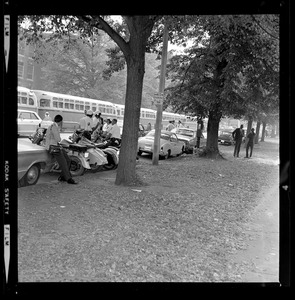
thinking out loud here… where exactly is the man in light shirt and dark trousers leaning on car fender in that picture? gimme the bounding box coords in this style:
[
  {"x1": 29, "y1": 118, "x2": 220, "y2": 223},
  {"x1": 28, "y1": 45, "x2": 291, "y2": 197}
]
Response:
[{"x1": 45, "y1": 115, "x2": 77, "y2": 184}]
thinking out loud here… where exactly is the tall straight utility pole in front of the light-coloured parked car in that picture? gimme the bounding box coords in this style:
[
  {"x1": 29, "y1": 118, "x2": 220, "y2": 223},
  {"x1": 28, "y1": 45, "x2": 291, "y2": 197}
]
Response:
[{"x1": 152, "y1": 20, "x2": 168, "y2": 165}]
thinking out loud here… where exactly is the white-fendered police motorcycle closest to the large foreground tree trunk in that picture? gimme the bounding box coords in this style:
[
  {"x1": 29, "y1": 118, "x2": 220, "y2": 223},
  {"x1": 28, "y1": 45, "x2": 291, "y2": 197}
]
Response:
[{"x1": 69, "y1": 129, "x2": 119, "y2": 172}]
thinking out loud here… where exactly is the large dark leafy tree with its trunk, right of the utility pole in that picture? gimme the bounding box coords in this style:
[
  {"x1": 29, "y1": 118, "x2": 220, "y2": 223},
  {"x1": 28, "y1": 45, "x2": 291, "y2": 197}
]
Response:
[{"x1": 166, "y1": 15, "x2": 279, "y2": 153}]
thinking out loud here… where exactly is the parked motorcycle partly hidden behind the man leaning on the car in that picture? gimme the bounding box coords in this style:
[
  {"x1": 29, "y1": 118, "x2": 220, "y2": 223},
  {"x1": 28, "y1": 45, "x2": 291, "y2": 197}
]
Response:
[{"x1": 29, "y1": 127, "x2": 90, "y2": 176}]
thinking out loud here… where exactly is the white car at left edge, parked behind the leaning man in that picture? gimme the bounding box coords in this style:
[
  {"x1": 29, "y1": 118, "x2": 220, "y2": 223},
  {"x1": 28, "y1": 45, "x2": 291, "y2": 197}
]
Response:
[{"x1": 17, "y1": 109, "x2": 42, "y2": 136}]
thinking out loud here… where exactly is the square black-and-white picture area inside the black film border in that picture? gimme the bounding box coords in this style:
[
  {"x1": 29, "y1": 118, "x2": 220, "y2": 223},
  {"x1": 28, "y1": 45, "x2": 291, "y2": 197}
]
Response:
[{"x1": 3, "y1": 0, "x2": 290, "y2": 296}]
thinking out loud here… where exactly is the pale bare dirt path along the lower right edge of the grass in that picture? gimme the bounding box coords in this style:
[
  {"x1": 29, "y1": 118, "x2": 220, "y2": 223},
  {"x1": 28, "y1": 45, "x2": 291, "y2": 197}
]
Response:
[{"x1": 233, "y1": 176, "x2": 279, "y2": 282}]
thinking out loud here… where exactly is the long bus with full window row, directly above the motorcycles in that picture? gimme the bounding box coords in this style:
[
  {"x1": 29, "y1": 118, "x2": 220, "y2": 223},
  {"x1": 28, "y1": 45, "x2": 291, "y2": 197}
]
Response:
[{"x1": 33, "y1": 90, "x2": 117, "y2": 122}]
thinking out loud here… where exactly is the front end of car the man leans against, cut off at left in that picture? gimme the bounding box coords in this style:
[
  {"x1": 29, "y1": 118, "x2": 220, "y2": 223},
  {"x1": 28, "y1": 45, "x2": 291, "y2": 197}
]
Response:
[{"x1": 17, "y1": 138, "x2": 51, "y2": 187}]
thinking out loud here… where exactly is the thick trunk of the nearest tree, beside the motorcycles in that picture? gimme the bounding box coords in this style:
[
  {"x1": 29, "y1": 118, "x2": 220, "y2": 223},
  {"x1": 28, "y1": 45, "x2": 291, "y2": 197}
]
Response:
[{"x1": 115, "y1": 24, "x2": 147, "y2": 185}]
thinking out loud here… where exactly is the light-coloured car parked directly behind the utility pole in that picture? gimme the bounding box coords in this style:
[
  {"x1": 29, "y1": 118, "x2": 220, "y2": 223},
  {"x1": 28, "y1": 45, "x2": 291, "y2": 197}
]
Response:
[{"x1": 138, "y1": 130, "x2": 185, "y2": 158}]
